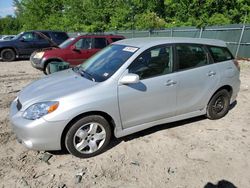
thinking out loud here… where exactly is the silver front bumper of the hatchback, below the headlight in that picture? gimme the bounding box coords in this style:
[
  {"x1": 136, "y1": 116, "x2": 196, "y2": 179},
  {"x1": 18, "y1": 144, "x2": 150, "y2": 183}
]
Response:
[{"x1": 10, "y1": 99, "x2": 67, "y2": 151}]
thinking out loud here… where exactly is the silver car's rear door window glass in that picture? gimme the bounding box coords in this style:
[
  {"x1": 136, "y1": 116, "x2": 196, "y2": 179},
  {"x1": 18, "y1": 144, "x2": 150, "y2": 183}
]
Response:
[{"x1": 176, "y1": 44, "x2": 209, "y2": 70}]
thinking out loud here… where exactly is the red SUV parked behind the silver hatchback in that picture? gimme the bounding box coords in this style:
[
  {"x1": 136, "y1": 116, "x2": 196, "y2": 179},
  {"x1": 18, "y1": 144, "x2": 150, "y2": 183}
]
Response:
[{"x1": 30, "y1": 35, "x2": 125, "y2": 74}]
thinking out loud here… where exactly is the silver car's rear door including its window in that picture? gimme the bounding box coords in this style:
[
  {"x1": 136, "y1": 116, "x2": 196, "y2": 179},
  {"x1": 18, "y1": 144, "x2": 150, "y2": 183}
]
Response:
[{"x1": 175, "y1": 44, "x2": 219, "y2": 115}]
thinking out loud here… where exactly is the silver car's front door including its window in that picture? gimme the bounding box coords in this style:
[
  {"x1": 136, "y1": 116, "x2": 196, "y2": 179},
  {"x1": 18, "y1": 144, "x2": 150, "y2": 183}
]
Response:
[{"x1": 118, "y1": 46, "x2": 177, "y2": 128}]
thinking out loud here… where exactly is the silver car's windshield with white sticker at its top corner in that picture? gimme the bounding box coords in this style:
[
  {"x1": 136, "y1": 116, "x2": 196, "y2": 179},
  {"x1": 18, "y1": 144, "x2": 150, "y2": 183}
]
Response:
[{"x1": 75, "y1": 44, "x2": 138, "y2": 82}]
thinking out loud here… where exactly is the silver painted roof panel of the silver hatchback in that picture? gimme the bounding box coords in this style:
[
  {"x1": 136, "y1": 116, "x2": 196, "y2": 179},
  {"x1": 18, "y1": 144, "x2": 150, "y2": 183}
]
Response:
[{"x1": 114, "y1": 37, "x2": 226, "y2": 48}]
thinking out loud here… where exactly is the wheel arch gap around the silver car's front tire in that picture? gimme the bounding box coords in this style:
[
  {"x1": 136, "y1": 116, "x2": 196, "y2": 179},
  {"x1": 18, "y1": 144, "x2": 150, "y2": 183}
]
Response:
[{"x1": 60, "y1": 111, "x2": 115, "y2": 150}]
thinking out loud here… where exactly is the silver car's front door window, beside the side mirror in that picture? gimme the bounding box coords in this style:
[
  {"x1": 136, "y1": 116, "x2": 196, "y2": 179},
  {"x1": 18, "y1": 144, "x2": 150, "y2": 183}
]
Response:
[{"x1": 128, "y1": 46, "x2": 173, "y2": 79}]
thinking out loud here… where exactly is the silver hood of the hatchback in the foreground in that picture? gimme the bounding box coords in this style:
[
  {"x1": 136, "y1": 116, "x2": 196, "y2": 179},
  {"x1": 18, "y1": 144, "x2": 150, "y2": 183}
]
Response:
[{"x1": 18, "y1": 69, "x2": 97, "y2": 109}]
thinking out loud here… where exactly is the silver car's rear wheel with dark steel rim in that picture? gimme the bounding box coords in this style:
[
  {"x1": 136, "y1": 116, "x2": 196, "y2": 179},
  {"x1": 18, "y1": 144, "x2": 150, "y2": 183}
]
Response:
[{"x1": 207, "y1": 89, "x2": 230, "y2": 120}]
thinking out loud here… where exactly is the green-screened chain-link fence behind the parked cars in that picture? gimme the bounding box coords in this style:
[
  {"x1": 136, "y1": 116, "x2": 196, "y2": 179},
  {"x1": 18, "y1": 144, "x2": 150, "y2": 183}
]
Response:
[{"x1": 70, "y1": 24, "x2": 250, "y2": 58}]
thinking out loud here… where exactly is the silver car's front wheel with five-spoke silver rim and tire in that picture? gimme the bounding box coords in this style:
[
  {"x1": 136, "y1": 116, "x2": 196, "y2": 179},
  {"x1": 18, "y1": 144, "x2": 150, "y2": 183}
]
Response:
[{"x1": 65, "y1": 115, "x2": 111, "y2": 158}]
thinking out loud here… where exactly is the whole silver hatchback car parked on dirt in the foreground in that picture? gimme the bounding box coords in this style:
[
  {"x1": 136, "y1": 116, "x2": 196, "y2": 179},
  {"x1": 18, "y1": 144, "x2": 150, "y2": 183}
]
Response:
[{"x1": 10, "y1": 38, "x2": 240, "y2": 158}]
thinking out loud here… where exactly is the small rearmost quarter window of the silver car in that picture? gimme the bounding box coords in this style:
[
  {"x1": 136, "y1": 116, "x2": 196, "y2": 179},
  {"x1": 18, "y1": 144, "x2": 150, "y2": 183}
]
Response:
[{"x1": 208, "y1": 46, "x2": 234, "y2": 63}]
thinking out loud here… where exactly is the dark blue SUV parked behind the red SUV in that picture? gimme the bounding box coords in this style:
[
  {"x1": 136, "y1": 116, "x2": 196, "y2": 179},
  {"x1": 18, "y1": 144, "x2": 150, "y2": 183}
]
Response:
[{"x1": 0, "y1": 31, "x2": 69, "y2": 61}]
